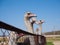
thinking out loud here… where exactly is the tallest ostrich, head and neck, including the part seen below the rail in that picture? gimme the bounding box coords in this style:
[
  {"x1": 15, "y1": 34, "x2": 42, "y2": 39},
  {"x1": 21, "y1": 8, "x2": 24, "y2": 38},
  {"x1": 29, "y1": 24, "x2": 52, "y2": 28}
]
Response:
[{"x1": 24, "y1": 12, "x2": 36, "y2": 45}]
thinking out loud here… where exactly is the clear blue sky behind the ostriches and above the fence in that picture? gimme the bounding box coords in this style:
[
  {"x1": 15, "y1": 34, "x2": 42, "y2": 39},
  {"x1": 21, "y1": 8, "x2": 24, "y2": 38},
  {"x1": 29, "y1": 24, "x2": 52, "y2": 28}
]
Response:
[{"x1": 0, "y1": 0, "x2": 60, "y2": 32}]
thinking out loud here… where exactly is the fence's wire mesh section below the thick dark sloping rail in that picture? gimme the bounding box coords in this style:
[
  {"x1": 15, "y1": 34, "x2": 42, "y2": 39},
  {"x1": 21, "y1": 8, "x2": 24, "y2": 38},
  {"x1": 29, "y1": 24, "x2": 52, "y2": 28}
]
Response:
[{"x1": 0, "y1": 28, "x2": 46, "y2": 45}]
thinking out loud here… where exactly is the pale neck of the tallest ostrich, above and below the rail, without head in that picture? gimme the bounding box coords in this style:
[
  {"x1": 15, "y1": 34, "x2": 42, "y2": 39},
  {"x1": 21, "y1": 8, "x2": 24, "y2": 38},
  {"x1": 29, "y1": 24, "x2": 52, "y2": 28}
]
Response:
[{"x1": 24, "y1": 17, "x2": 35, "y2": 45}]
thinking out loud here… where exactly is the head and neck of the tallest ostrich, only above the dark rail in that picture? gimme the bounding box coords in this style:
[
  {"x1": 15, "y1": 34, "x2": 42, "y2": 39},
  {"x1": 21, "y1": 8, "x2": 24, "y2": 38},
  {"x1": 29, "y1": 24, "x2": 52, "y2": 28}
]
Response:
[{"x1": 24, "y1": 12, "x2": 36, "y2": 33}]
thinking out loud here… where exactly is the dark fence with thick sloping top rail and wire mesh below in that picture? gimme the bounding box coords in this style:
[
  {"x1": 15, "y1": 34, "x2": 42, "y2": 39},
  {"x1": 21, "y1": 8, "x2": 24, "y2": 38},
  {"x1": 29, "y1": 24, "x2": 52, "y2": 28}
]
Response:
[{"x1": 0, "y1": 21, "x2": 46, "y2": 45}]
